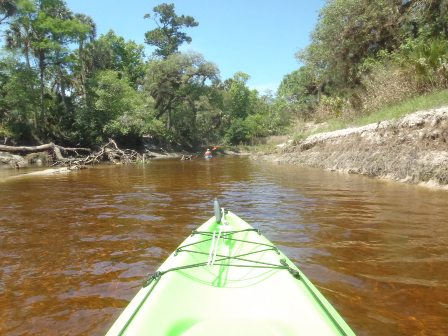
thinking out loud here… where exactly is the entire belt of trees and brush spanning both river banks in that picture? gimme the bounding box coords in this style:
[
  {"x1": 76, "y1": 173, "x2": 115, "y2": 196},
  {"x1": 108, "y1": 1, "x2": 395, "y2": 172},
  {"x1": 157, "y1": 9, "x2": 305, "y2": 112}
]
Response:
[{"x1": 0, "y1": 0, "x2": 448, "y2": 149}]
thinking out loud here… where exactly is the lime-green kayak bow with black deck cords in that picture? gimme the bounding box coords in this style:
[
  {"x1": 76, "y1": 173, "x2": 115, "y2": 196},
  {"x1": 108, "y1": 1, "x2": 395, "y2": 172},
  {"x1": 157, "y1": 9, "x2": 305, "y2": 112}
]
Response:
[{"x1": 107, "y1": 201, "x2": 355, "y2": 336}]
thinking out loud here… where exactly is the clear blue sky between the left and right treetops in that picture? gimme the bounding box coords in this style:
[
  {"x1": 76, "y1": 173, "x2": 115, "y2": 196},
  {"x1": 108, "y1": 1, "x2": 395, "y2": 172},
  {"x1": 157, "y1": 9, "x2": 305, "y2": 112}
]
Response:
[{"x1": 66, "y1": 0, "x2": 325, "y2": 92}]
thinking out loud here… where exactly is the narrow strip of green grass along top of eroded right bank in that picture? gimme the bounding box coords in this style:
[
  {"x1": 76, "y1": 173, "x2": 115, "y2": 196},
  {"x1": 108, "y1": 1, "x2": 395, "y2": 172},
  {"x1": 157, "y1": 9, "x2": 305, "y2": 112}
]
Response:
[{"x1": 293, "y1": 90, "x2": 448, "y2": 141}]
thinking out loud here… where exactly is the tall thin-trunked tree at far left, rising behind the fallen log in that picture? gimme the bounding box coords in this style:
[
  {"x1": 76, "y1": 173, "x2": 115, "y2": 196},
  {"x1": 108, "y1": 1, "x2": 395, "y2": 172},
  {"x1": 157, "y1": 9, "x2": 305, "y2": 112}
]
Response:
[{"x1": 6, "y1": 0, "x2": 96, "y2": 142}]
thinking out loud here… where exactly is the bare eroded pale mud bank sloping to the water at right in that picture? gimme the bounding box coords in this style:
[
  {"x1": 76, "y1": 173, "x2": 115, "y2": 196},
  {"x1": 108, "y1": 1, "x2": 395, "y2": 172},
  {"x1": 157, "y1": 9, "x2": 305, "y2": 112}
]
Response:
[{"x1": 255, "y1": 107, "x2": 448, "y2": 189}]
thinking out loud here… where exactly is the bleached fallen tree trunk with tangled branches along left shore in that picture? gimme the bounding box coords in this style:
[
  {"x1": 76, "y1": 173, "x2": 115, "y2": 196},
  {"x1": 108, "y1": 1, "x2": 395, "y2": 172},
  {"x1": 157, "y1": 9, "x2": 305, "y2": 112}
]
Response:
[{"x1": 0, "y1": 139, "x2": 142, "y2": 169}]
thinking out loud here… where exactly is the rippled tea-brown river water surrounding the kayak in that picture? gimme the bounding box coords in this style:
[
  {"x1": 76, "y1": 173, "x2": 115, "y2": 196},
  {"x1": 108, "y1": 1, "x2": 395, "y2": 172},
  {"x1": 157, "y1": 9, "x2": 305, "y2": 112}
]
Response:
[{"x1": 0, "y1": 158, "x2": 448, "y2": 335}]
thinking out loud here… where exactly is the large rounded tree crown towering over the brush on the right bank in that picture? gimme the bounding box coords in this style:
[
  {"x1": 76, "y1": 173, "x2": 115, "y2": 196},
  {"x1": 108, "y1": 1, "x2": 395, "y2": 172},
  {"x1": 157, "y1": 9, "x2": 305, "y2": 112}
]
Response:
[{"x1": 297, "y1": 0, "x2": 402, "y2": 87}]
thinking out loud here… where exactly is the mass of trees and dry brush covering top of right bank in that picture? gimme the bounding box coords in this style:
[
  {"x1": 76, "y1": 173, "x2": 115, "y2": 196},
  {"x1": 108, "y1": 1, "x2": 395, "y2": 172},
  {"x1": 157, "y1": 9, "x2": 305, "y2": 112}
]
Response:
[{"x1": 278, "y1": 0, "x2": 448, "y2": 127}]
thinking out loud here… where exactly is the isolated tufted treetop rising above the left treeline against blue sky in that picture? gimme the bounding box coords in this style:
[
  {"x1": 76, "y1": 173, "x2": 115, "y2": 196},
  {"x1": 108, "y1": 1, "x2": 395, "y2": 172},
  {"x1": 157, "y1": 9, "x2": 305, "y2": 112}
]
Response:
[{"x1": 144, "y1": 3, "x2": 199, "y2": 58}]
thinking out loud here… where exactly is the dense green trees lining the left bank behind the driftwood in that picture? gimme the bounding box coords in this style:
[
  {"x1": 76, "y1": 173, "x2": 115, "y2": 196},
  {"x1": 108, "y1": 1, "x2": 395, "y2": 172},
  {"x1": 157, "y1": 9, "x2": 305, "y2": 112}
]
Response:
[{"x1": 0, "y1": 0, "x2": 290, "y2": 148}]
